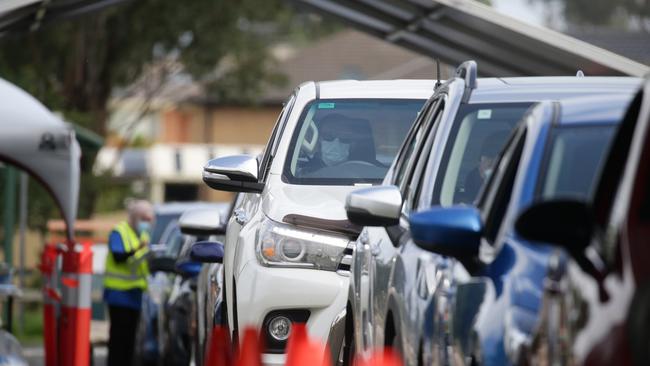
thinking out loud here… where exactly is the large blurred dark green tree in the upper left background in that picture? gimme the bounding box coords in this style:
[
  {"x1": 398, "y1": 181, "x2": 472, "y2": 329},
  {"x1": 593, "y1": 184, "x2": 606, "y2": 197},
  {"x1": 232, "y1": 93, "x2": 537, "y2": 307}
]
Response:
[{"x1": 0, "y1": 0, "x2": 331, "y2": 228}]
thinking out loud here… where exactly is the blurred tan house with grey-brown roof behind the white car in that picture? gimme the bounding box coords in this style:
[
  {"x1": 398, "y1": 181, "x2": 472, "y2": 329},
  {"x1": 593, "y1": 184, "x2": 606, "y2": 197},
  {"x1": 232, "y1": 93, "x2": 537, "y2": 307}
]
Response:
[{"x1": 95, "y1": 30, "x2": 452, "y2": 203}]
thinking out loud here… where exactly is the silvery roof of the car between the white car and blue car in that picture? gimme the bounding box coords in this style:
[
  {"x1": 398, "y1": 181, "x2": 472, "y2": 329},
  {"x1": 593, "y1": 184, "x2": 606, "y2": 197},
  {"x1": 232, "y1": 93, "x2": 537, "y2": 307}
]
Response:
[{"x1": 469, "y1": 76, "x2": 643, "y2": 103}]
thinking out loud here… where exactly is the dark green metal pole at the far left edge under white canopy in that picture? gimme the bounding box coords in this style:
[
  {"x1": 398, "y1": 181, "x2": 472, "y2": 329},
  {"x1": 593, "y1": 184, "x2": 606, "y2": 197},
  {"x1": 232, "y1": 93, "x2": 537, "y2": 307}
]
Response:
[{"x1": 3, "y1": 165, "x2": 16, "y2": 333}]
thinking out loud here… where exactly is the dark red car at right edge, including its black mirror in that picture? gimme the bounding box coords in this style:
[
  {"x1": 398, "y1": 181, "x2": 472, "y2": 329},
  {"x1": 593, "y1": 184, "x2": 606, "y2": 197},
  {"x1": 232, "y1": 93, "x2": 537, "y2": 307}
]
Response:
[{"x1": 516, "y1": 79, "x2": 650, "y2": 365}]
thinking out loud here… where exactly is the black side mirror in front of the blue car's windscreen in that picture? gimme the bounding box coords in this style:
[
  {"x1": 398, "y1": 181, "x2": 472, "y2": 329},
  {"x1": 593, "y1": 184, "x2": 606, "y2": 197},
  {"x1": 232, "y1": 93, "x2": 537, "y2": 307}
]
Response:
[{"x1": 515, "y1": 199, "x2": 595, "y2": 257}]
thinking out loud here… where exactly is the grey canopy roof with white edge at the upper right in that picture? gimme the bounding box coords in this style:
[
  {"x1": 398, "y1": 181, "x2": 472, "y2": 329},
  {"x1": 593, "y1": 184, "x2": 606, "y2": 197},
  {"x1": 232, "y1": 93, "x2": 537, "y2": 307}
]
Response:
[{"x1": 292, "y1": 0, "x2": 650, "y2": 76}]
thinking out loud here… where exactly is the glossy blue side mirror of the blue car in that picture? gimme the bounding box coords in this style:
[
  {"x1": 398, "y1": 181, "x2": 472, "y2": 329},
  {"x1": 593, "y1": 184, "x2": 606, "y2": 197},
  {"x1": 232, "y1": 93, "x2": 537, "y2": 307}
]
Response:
[{"x1": 409, "y1": 205, "x2": 483, "y2": 262}]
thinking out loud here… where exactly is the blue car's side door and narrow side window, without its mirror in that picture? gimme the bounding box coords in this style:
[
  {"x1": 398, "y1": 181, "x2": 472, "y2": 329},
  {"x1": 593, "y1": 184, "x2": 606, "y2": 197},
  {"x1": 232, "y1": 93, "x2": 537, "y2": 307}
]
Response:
[{"x1": 446, "y1": 125, "x2": 526, "y2": 364}]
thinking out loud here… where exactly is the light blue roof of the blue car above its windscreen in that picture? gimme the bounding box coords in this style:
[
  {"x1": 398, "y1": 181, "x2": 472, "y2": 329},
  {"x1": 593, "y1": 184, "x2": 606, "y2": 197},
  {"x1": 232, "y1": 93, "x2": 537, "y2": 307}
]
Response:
[{"x1": 558, "y1": 93, "x2": 634, "y2": 125}]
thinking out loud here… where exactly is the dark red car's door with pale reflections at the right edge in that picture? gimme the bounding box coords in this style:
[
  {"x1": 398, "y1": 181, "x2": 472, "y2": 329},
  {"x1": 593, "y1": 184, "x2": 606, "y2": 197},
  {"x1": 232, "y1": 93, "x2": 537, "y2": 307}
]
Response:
[{"x1": 561, "y1": 86, "x2": 650, "y2": 365}]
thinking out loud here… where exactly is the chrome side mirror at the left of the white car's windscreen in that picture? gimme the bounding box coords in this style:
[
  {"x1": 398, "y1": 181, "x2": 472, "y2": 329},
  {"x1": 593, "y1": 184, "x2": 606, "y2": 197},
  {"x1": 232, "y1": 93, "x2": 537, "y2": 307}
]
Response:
[{"x1": 203, "y1": 155, "x2": 264, "y2": 193}]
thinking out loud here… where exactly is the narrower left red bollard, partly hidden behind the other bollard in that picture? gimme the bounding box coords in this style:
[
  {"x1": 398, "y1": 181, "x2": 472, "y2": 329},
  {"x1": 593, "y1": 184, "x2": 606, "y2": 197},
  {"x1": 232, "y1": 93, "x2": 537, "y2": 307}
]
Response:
[{"x1": 39, "y1": 243, "x2": 61, "y2": 366}]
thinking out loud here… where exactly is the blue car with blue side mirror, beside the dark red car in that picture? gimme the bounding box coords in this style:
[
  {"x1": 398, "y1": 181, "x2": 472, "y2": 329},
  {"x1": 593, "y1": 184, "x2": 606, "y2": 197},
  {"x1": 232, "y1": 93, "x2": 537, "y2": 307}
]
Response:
[{"x1": 410, "y1": 93, "x2": 632, "y2": 365}]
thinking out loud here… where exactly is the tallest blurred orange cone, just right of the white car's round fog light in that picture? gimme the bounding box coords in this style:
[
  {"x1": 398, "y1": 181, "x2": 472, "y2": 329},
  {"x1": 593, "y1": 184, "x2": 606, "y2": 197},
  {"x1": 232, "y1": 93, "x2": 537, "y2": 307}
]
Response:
[{"x1": 285, "y1": 324, "x2": 332, "y2": 366}]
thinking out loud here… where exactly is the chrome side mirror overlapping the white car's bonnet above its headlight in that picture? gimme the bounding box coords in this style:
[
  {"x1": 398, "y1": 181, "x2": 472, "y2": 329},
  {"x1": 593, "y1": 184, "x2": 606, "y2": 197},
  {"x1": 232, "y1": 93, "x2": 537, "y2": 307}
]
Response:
[{"x1": 345, "y1": 186, "x2": 402, "y2": 226}]
